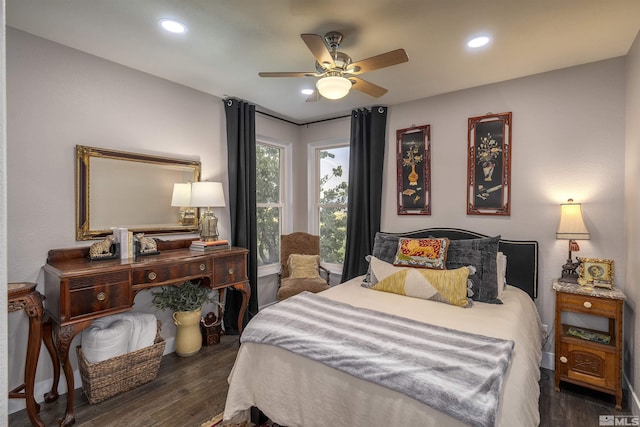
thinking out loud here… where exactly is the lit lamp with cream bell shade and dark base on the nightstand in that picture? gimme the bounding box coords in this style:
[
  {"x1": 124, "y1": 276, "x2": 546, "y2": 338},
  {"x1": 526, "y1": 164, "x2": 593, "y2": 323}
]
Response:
[{"x1": 556, "y1": 199, "x2": 590, "y2": 283}]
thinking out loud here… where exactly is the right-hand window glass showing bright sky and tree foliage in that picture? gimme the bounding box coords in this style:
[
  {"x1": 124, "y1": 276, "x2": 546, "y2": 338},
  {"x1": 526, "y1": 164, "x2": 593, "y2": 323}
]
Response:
[{"x1": 313, "y1": 143, "x2": 349, "y2": 270}]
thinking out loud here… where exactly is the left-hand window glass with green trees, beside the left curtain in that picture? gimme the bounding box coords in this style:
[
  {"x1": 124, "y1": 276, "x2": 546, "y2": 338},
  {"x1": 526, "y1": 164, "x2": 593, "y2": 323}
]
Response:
[{"x1": 256, "y1": 142, "x2": 285, "y2": 267}]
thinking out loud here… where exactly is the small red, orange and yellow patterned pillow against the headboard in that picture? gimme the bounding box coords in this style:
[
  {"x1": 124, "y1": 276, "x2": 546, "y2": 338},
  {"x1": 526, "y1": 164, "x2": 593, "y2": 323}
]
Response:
[{"x1": 393, "y1": 237, "x2": 449, "y2": 270}]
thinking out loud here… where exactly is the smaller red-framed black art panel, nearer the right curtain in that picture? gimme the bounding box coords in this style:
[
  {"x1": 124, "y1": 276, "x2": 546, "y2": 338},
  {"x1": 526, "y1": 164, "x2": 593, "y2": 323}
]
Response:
[{"x1": 396, "y1": 125, "x2": 431, "y2": 215}]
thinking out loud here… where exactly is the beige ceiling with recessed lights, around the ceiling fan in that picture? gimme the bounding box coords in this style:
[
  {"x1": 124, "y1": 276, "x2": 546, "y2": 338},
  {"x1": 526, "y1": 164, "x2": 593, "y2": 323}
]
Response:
[{"x1": 6, "y1": 0, "x2": 640, "y2": 124}]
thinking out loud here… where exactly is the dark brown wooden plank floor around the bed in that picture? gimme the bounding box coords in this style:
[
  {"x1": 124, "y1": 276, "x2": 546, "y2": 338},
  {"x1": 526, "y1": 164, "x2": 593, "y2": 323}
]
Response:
[{"x1": 9, "y1": 336, "x2": 631, "y2": 427}]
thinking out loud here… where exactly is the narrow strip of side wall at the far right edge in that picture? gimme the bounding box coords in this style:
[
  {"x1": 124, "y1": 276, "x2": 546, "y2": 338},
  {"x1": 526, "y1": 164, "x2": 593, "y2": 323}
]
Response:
[{"x1": 624, "y1": 29, "x2": 640, "y2": 415}]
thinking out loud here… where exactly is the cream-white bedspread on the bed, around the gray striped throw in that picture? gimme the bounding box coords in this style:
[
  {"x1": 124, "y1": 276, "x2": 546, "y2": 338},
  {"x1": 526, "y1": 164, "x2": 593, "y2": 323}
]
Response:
[{"x1": 224, "y1": 277, "x2": 542, "y2": 427}]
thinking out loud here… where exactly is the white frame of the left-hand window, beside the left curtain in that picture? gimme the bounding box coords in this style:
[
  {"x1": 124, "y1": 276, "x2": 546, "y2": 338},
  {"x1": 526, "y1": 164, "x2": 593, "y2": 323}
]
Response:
[{"x1": 256, "y1": 135, "x2": 293, "y2": 277}]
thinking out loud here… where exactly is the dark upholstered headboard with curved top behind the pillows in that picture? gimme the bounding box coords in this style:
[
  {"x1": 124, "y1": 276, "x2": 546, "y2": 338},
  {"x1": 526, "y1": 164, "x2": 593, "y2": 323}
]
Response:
[{"x1": 383, "y1": 228, "x2": 538, "y2": 298}]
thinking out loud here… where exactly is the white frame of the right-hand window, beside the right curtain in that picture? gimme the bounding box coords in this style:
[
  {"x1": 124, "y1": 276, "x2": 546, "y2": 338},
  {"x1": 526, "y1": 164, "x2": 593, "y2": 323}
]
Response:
[{"x1": 307, "y1": 138, "x2": 351, "y2": 275}]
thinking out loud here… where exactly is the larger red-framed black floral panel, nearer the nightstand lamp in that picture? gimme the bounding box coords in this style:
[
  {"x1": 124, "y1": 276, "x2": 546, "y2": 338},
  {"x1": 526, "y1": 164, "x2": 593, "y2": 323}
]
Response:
[{"x1": 467, "y1": 112, "x2": 511, "y2": 216}]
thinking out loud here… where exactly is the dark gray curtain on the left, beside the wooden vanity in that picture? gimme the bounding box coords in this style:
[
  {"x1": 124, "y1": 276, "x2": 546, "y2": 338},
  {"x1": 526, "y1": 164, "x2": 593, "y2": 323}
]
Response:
[{"x1": 224, "y1": 99, "x2": 258, "y2": 335}]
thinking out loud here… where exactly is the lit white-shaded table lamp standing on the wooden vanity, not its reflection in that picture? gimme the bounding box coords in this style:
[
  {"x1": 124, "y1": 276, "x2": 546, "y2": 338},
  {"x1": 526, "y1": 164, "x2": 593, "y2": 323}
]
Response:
[{"x1": 189, "y1": 181, "x2": 226, "y2": 242}]
